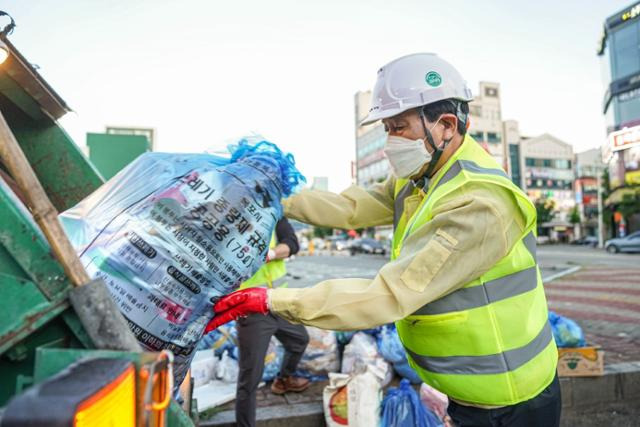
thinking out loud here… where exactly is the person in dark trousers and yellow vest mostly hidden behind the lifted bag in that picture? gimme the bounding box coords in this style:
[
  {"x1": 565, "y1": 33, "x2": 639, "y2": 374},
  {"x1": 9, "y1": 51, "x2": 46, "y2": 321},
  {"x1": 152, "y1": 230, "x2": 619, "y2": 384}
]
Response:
[{"x1": 236, "y1": 217, "x2": 310, "y2": 427}]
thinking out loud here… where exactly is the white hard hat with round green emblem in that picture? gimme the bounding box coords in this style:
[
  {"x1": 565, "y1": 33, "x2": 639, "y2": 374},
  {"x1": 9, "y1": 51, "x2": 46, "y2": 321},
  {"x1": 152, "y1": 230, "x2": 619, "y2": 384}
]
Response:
[{"x1": 360, "y1": 53, "x2": 473, "y2": 125}]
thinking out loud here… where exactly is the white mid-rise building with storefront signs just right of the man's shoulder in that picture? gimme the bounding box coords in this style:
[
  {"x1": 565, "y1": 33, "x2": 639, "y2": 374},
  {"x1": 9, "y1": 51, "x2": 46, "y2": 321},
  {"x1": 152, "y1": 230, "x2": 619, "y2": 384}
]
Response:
[{"x1": 518, "y1": 133, "x2": 576, "y2": 240}]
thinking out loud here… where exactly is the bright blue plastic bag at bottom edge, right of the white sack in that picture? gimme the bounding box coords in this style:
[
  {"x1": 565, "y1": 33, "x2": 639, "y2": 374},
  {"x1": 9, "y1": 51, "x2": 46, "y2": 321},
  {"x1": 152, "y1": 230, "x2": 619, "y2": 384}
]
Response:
[{"x1": 380, "y1": 380, "x2": 442, "y2": 427}]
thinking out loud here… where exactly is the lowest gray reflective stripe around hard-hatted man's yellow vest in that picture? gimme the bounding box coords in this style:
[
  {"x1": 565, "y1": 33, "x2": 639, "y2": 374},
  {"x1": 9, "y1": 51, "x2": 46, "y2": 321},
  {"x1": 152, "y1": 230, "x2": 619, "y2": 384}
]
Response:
[{"x1": 405, "y1": 322, "x2": 553, "y2": 375}]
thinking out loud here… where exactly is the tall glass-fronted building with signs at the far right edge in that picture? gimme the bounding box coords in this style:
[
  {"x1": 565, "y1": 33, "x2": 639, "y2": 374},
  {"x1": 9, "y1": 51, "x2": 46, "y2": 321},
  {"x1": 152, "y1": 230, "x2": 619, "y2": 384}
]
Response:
[{"x1": 598, "y1": 3, "x2": 640, "y2": 235}]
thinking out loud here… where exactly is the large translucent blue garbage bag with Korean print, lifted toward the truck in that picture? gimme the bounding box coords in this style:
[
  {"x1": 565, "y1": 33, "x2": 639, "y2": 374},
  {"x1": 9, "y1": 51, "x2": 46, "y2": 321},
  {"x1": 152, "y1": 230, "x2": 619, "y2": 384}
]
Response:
[{"x1": 60, "y1": 139, "x2": 304, "y2": 385}]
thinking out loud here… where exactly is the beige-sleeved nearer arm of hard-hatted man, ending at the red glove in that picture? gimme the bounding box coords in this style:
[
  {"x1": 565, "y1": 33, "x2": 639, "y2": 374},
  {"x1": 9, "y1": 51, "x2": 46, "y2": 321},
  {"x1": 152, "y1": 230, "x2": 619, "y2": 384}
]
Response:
[{"x1": 269, "y1": 187, "x2": 524, "y2": 330}]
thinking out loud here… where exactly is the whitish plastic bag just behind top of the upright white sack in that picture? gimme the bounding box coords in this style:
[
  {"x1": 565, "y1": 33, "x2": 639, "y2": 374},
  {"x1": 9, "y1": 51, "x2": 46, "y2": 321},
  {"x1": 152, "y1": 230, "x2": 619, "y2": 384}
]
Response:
[{"x1": 340, "y1": 332, "x2": 393, "y2": 387}]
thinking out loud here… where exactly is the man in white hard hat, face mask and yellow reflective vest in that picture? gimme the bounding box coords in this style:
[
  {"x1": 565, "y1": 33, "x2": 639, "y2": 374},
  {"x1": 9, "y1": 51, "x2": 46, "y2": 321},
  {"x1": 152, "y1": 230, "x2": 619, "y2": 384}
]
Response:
[{"x1": 206, "y1": 53, "x2": 561, "y2": 427}]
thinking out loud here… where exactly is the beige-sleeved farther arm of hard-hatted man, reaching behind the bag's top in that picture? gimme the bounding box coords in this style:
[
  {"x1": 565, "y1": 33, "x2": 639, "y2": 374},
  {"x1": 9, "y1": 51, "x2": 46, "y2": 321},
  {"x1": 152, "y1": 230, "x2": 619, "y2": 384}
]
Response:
[{"x1": 282, "y1": 178, "x2": 395, "y2": 229}]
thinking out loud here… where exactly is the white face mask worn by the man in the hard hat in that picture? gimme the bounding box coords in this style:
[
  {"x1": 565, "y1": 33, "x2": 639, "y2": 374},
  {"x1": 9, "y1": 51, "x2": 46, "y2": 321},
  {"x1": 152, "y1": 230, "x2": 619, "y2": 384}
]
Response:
[{"x1": 383, "y1": 119, "x2": 440, "y2": 179}]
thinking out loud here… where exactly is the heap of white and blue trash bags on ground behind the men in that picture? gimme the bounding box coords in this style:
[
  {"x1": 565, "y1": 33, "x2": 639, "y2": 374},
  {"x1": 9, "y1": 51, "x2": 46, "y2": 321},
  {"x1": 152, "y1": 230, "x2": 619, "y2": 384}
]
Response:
[{"x1": 198, "y1": 322, "x2": 449, "y2": 427}]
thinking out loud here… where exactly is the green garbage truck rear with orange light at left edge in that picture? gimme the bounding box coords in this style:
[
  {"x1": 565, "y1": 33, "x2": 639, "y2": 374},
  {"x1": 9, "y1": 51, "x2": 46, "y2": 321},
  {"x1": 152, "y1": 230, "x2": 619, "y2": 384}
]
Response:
[{"x1": 0, "y1": 34, "x2": 197, "y2": 426}]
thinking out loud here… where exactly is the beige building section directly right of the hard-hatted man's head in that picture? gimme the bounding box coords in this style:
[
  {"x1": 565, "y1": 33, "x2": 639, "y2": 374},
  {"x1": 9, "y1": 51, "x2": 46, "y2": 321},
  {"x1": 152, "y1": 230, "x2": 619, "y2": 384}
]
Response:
[{"x1": 469, "y1": 82, "x2": 507, "y2": 169}]
